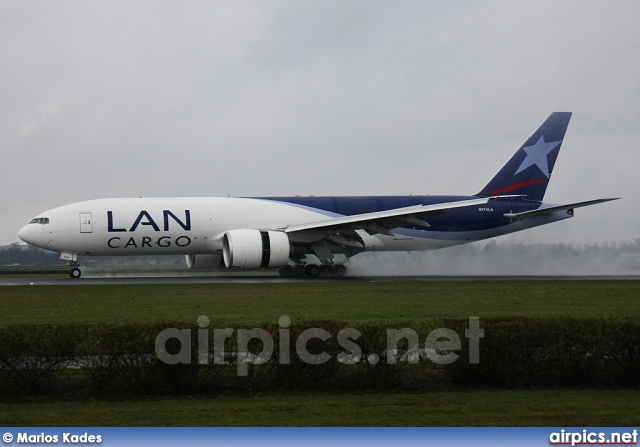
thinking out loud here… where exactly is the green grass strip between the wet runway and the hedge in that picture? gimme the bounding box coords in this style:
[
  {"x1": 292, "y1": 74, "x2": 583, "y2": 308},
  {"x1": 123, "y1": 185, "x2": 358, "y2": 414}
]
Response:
[{"x1": 0, "y1": 280, "x2": 640, "y2": 327}]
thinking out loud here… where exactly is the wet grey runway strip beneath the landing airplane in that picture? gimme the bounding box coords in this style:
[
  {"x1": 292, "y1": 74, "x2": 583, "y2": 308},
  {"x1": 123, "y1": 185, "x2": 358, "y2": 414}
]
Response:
[{"x1": 0, "y1": 275, "x2": 640, "y2": 286}]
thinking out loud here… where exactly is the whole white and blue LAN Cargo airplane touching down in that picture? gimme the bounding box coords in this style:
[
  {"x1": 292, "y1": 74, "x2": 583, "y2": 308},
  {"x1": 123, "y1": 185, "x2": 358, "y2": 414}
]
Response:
[{"x1": 18, "y1": 112, "x2": 615, "y2": 278}]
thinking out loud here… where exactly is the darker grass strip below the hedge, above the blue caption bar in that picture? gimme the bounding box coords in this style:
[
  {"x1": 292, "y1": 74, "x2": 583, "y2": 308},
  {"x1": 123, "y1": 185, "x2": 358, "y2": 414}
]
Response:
[{"x1": 0, "y1": 390, "x2": 640, "y2": 427}]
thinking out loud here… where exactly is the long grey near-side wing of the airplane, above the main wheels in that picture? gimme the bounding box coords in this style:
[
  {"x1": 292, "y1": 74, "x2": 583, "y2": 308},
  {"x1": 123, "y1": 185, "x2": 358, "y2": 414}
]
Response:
[{"x1": 282, "y1": 197, "x2": 493, "y2": 242}]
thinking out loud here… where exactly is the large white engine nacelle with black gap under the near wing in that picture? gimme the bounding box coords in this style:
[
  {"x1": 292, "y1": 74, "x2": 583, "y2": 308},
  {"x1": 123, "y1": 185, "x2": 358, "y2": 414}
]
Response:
[{"x1": 222, "y1": 230, "x2": 291, "y2": 270}]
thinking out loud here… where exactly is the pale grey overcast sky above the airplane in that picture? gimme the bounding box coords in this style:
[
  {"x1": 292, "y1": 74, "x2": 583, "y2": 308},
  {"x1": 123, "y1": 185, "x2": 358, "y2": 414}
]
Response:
[{"x1": 0, "y1": 0, "x2": 640, "y2": 244}]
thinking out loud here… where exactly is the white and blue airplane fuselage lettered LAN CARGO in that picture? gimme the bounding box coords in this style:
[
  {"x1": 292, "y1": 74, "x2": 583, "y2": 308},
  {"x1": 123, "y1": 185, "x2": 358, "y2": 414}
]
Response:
[{"x1": 20, "y1": 196, "x2": 571, "y2": 256}]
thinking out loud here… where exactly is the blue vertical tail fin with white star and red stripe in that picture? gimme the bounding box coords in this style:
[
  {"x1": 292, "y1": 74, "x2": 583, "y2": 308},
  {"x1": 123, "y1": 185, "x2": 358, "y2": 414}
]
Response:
[{"x1": 477, "y1": 112, "x2": 571, "y2": 201}]
